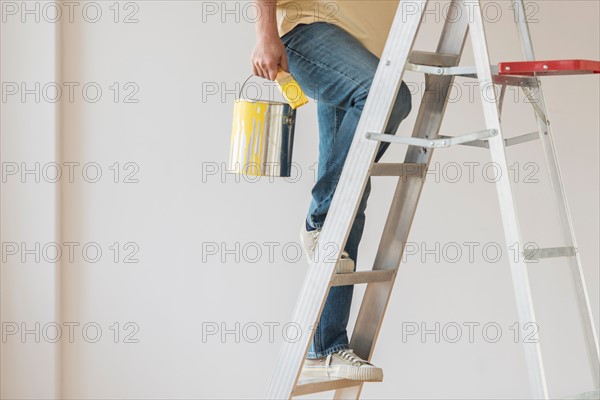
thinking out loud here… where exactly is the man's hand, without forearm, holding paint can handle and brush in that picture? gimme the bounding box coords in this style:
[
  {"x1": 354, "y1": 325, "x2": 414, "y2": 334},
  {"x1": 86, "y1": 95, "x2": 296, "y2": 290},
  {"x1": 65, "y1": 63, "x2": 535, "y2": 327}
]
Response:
[{"x1": 252, "y1": 35, "x2": 288, "y2": 81}]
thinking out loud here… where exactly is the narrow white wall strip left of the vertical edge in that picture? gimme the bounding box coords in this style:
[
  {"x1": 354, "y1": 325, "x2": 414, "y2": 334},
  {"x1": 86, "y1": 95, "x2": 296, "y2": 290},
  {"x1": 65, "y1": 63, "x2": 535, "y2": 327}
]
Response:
[{"x1": 0, "y1": 2, "x2": 59, "y2": 399}]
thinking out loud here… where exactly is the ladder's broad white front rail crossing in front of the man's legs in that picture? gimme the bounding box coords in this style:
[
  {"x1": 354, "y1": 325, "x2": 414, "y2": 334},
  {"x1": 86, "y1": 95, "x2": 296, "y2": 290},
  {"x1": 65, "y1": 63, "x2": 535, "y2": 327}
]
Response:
[{"x1": 266, "y1": 0, "x2": 427, "y2": 399}]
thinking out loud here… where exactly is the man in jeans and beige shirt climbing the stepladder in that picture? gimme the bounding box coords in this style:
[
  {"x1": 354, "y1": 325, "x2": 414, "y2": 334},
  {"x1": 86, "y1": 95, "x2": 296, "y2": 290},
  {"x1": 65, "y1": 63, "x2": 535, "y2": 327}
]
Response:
[{"x1": 252, "y1": 0, "x2": 411, "y2": 381}]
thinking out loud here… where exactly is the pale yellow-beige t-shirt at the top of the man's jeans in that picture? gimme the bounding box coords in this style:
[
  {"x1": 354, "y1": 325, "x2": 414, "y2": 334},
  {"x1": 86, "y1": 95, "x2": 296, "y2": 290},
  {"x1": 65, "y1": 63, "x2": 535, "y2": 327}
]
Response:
[{"x1": 277, "y1": 0, "x2": 399, "y2": 57}]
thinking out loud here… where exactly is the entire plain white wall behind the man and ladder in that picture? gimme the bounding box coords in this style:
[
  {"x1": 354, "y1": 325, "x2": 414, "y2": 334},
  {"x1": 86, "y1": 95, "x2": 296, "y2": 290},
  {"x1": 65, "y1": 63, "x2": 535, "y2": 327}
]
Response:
[{"x1": 2, "y1": 1, "x2": 600, "y2": 398}]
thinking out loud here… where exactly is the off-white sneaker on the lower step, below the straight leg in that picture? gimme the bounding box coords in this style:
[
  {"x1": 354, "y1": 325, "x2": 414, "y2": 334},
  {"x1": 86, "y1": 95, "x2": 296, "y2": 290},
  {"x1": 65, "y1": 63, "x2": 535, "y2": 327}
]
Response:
[{"x1": 302, "y1": 350, "x2": 383, "y2": 382}]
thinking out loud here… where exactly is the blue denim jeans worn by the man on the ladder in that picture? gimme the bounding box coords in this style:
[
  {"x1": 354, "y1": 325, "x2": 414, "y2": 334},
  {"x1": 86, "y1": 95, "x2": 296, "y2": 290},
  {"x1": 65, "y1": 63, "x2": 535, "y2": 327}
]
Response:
[{"x1": 282, "y1": 22, "x2": 411, "y2": 359}]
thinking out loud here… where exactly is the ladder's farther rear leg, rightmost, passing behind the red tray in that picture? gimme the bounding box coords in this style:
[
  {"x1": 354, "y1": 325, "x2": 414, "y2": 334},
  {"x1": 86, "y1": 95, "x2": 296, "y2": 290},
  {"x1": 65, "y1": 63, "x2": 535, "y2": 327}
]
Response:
[{"x1": 513, "y1": 0, "x2": 600, "y2": 388}]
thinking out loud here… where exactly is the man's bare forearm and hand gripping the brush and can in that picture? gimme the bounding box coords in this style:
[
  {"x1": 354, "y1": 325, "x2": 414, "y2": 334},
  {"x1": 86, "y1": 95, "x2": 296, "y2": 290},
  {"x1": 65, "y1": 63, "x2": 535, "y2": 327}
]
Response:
[{"x1": 252, "y1": 0, "x2": 289, "y2": 81}]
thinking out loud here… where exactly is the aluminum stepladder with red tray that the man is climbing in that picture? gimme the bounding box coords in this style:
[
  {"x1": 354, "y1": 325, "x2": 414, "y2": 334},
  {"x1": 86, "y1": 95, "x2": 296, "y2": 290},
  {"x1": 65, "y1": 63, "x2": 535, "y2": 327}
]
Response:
[{"x1": 266, "y1": 0, "x2": 600, "y2": 399}]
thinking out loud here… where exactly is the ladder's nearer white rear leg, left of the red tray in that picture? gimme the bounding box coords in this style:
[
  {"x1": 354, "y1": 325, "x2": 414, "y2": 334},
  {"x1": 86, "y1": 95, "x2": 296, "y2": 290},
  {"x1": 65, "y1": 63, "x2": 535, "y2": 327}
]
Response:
[{"x1": 464, "y1": 0, "x2": 548, "y2": 399}]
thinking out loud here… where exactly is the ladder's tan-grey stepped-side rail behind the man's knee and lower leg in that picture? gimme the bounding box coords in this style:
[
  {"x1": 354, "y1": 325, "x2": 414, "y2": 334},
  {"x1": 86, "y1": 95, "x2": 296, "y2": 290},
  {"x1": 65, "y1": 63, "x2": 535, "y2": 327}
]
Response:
[{"x1": 334, "y1": 0, "x2": 469, "y2": 399}]
